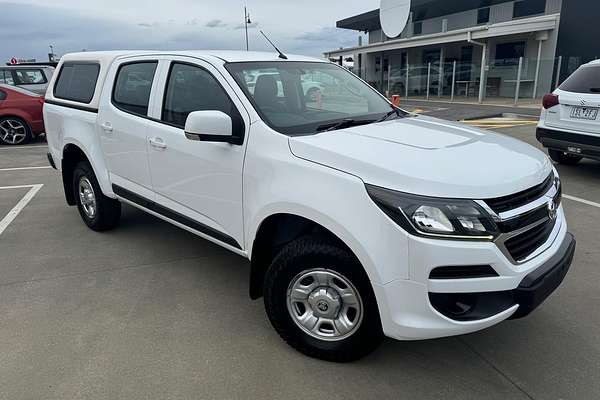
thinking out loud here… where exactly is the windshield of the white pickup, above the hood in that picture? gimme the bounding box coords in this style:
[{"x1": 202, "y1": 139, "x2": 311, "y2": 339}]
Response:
[{"x1": 226, "y1": 61, "x2": 405, "y2": 135}]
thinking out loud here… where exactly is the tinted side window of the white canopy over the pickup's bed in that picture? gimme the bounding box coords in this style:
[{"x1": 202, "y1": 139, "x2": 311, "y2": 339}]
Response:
[{"x1": 54, "y1": 63, "x2": 100, "y2": 104}]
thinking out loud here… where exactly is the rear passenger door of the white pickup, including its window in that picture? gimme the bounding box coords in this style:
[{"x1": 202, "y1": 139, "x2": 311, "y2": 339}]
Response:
[{"x1": 98, "y1": 57, "x2": 159, "y2": 199}]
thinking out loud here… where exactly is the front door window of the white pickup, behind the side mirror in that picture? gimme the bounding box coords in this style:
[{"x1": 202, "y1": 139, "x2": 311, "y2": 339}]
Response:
[{"x1": 161, "y1": 63, "x2": 243, "y2": 133}]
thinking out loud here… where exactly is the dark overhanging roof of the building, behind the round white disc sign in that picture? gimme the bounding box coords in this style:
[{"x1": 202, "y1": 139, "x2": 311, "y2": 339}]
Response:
[{"x1": 336, "y1": 0, "x2": 511, "y2": 32}]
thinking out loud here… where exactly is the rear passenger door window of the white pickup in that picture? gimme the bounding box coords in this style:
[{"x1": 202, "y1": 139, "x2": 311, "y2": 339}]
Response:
[{"x1": 112, "y1": 61, "x2": 158, "y2": 116}]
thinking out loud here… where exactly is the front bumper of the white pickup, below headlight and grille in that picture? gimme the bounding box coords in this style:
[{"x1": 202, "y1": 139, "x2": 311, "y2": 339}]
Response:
[{"x1": 373, "y1": 207, "x2": 575, "y2": 340}]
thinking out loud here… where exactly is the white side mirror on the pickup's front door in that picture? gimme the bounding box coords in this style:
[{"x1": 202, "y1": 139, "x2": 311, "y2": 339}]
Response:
[{"x1": 185, "y1": 111, "x2": 236, "y2": 143}]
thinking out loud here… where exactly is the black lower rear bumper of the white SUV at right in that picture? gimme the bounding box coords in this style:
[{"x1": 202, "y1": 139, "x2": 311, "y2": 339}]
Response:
[{"x1": 536, "y1": 128, "x2": 600, "y2": 160}]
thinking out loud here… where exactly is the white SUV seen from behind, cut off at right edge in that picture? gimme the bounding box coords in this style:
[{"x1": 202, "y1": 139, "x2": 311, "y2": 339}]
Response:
[{"x1": 537, "y1": 61, "x2": 600, "y2": 165}]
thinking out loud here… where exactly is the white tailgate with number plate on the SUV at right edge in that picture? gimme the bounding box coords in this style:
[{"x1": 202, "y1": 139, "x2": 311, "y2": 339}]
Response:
[{"x1": 546, "y1": 64, "x2": 600, "y2": 134}]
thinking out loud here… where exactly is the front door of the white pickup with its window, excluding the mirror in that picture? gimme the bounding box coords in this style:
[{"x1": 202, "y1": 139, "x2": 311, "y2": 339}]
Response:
[{"x1": 148, "y1": 58, "x2": 249, "y2": 249}]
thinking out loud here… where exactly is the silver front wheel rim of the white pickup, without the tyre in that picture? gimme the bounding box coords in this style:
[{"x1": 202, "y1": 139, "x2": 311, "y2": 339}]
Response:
[{"x1": 287, "y1": 269, "x2": 363, "y2": 341}]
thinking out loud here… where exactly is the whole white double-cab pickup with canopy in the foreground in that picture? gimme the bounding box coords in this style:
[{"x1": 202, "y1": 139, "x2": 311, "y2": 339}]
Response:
[{"x1": 44, "y1": 51, "x2": 575, "y2": 361}]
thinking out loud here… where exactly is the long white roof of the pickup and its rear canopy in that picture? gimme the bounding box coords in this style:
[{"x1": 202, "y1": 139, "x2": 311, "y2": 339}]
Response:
[{"x1": 61, "y1": 50, "x2": 327, "y2": 62}]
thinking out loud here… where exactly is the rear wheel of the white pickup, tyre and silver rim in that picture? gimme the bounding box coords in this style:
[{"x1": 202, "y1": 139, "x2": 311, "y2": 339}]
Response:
[{"x1": 73, "y1": 161, "x2": 121, "y2": 232}]
